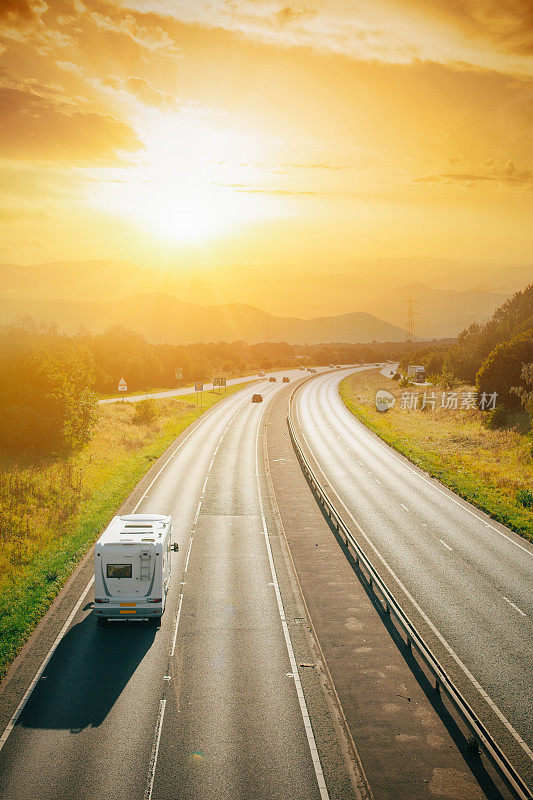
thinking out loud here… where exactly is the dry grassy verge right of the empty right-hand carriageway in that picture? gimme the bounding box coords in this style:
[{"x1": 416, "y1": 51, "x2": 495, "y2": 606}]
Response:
[{"x1": 340, "y1": 372, "x2": 533, "y2": 541}]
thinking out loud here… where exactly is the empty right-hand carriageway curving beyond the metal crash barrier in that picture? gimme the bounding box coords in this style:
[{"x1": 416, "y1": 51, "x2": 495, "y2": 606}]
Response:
[{"x1": 295, "y1": 370, "x2": 533, "y2": 780}]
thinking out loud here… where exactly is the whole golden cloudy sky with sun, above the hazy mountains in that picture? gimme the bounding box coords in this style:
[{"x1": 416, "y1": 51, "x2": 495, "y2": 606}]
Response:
[{"x1": 0, "y1": 0, "x2": 533, "y2": 288}]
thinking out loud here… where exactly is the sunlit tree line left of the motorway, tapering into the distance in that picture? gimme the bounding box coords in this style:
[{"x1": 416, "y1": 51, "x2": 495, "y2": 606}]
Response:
[{"x1": 0, "y1": 318, "x2": 444, "y2": 454}]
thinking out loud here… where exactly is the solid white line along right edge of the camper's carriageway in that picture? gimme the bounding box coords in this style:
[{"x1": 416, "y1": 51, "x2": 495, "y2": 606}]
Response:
[{"x1": 255, "y1": 412, "x2": 329, "y2": 800}]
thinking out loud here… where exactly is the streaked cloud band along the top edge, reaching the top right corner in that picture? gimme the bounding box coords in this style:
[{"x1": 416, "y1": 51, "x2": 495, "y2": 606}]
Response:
[{"x1": 116, "y1": 0, "x2": 533, "y2": 74}]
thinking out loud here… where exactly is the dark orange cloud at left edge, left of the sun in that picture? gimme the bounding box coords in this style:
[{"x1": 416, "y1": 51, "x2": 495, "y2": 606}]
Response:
[{"x1": 0, "y1": 86, "x2": 140, "y2": 163}]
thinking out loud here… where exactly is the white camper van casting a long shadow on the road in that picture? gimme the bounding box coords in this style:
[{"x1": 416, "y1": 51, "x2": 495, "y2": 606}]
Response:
[{"x1": 94, "y1": 514, "x2": 178, "y2": 623}]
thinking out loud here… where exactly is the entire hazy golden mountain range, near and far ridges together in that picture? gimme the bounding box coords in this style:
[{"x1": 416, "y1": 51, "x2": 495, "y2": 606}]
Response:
[{"x1": 0, "y1": 259, "x2": 533, "y2": 342}]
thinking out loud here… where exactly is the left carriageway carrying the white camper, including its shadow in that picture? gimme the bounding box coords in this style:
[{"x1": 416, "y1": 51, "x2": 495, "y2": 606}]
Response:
[{"x1": 0, "y1": 371, "x2": 355, "y2": 800}]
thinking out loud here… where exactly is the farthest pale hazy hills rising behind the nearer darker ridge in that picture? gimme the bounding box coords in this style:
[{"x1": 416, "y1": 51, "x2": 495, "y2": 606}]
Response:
[{"x1": 0, "y1": 258, "x2": 533, "y2": 338}]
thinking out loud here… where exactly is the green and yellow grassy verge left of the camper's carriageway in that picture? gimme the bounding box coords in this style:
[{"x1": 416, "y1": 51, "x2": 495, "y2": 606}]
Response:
[{"x1": 0, "y1": 384, "x2": 248, "y2": 678}]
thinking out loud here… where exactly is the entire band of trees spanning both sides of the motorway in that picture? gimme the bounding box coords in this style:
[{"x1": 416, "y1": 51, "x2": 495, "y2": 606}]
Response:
[{"x1": 0, "y1": 285, "x2": 533, "y2": 453}]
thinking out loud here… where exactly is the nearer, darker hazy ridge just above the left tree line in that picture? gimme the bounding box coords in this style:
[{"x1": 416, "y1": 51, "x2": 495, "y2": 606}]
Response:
[{"x1": 0, "y1": 293, "x2": 405, "y2": 344}]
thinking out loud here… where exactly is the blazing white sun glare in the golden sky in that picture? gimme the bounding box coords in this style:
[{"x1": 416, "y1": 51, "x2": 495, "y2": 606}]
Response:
[{"x1": 85, "y1": 112, "x2": 276, "y2": 242}]
